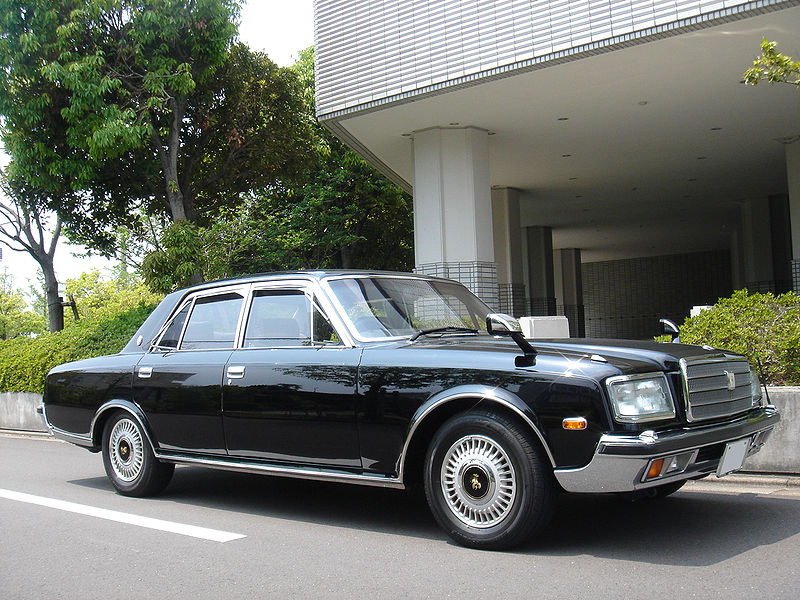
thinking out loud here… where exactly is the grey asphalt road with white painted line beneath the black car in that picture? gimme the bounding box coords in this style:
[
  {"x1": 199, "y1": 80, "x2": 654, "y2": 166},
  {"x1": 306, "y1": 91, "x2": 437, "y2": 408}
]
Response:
[{"x1": 0, "y1": 434, "x2": 800, "y2": 600}]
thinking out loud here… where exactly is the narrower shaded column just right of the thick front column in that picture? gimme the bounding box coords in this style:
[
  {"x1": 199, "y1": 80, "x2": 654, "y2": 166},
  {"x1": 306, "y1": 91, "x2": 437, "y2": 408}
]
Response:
[{"x1": 492, "y1": 188, "x2": 527, "y2": 317}]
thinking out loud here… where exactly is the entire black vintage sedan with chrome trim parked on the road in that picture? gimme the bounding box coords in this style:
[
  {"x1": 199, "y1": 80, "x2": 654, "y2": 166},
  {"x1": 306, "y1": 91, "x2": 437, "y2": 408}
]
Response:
[{"x1": 42, "y1": 272, "x2": 780, "y2": 548}]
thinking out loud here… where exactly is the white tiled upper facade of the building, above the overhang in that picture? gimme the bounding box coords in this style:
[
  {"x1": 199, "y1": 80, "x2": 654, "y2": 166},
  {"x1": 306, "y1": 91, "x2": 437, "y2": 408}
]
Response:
[{"x1": 315, "y1": 0, "x2": 791, "y2": 118}]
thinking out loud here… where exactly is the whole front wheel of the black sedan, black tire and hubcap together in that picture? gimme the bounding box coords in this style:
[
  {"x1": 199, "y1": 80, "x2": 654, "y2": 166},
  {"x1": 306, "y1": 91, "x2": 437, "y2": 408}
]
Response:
[{"x1": 424, "y1": 411, "x2": 556, "y2": 550}]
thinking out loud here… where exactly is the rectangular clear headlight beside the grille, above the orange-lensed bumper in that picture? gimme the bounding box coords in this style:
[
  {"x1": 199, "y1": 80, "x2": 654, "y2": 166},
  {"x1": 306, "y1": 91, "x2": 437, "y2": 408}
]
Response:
[{"x1": 606, "y1": 373, "x2": 675, "y2": 423}]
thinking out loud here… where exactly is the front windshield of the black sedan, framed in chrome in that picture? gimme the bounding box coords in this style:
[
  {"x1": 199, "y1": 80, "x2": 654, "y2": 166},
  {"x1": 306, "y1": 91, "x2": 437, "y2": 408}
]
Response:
[{"x1": 328, "y1": 277, "x2": 491, "y2": 340}]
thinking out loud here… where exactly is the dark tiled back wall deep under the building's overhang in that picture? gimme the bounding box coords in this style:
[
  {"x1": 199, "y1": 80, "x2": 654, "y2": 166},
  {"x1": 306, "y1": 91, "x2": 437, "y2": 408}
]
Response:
[{"x1": 583, "y1": 251, "x2": 732, "y2": 339}]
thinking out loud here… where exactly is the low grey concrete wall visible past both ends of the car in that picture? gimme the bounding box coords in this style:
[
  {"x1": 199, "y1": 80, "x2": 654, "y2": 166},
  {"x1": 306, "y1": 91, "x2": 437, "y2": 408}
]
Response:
[{"x1": 0, "y1": 387, "x2": 800, "y2": 474}]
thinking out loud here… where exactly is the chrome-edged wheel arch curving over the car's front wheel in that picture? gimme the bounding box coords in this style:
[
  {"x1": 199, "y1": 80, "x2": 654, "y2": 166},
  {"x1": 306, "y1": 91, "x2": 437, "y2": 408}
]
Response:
[{"x1": 397, "y1": 385, "x2": 555, "y2": 487}]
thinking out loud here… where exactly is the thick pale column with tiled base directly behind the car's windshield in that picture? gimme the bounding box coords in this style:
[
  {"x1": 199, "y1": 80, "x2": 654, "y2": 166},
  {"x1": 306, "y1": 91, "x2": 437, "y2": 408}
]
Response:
[{"x1": 413, "y1": 127, "x2": 499, "y2": 310}]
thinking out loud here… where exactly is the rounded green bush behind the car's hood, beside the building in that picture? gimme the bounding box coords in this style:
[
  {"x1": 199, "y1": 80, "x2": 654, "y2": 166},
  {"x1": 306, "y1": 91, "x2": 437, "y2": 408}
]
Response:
[{"x1": 680, "y1": 290, "x2": 800, "y2": 385}]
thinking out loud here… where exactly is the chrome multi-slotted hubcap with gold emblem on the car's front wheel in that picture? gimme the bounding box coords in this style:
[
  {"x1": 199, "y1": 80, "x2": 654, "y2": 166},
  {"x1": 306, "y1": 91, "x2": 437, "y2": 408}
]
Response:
[{"x1": 441, "y1": 435, "x2": 517, "y2": 528}]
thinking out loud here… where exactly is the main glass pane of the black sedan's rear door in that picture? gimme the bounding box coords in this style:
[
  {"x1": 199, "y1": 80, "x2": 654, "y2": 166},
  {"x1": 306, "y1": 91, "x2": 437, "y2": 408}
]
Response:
[{"x1": 181, "y1": 293, "x2": 242, "y2": 350}]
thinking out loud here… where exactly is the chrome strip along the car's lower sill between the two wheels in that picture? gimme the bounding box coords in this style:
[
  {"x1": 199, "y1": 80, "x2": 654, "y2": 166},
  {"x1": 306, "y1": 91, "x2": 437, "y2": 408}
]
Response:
[{"x1": 155, "y1": 452, "x2": 405, "y2": 490}]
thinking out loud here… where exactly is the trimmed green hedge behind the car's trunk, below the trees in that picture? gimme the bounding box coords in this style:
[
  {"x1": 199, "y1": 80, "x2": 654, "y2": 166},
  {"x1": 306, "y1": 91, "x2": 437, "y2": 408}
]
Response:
[{"x1": 0, "y1": 306, "x2": 155, "y2": 394}]
